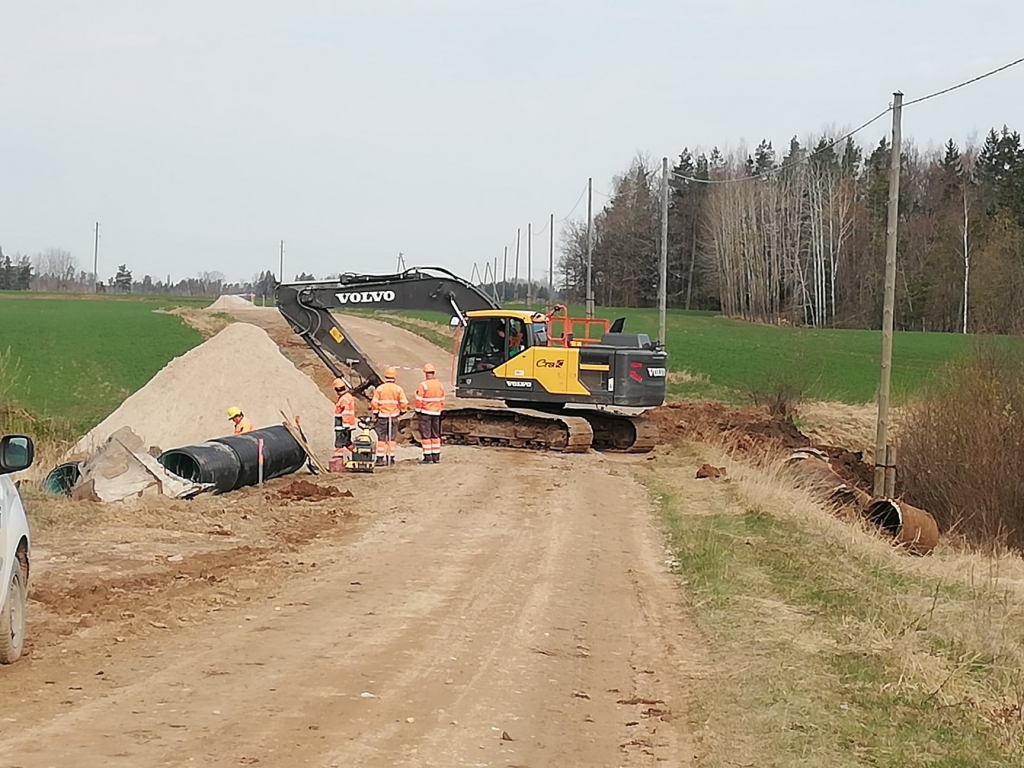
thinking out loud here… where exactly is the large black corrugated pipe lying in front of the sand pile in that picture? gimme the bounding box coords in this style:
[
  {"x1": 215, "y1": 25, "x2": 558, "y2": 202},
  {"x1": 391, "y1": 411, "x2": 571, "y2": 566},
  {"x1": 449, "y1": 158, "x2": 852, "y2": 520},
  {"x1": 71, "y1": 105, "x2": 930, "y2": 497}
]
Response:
[{"x1": 158, "y1": 426, "x2": 306, "y2": 494}]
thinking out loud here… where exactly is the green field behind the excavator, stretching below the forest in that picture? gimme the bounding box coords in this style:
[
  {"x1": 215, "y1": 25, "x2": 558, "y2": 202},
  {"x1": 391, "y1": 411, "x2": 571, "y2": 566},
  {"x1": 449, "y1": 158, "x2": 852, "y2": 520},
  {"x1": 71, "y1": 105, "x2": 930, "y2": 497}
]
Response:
[{"x1": 374, "y1": 306, "x2": 983, "y2": 403}]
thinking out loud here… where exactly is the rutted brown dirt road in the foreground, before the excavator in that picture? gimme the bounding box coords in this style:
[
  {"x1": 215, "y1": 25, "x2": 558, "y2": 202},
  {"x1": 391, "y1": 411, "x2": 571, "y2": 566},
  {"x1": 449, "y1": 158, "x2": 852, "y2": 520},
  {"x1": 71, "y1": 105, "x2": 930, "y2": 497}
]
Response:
[{"x1": 0, "y1": 313, "x2": 699, "y2": 768}]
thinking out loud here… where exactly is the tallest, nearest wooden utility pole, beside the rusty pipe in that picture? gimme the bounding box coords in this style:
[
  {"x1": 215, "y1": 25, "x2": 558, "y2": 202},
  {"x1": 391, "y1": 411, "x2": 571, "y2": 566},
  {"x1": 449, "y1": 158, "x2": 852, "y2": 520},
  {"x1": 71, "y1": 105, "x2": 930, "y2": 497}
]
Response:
[{"x1": 874, "y1": 91, "x2": 903, "y2": 496}]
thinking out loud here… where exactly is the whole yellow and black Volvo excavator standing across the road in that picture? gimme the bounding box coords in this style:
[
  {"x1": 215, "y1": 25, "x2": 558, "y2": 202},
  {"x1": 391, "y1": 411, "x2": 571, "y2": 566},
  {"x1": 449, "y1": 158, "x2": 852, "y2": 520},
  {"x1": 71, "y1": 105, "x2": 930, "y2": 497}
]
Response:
[{"x1": 275, "y1": 267, "x2": 668, "y2": 453}]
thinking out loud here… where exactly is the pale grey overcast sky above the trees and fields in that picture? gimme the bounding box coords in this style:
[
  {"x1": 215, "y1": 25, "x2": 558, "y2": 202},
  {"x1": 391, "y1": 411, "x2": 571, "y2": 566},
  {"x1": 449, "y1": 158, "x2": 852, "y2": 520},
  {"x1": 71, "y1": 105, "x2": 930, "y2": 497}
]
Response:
[{"x1": 0, "y1": 0, "x2": 1024, "y2": 281}]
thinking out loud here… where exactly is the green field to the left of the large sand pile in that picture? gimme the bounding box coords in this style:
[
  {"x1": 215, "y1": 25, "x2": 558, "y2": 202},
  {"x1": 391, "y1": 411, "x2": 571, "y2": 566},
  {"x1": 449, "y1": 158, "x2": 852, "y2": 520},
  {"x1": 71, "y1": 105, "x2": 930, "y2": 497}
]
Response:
[{"x1": 0, "y1": 293, "x2": 203, "y2": 434}]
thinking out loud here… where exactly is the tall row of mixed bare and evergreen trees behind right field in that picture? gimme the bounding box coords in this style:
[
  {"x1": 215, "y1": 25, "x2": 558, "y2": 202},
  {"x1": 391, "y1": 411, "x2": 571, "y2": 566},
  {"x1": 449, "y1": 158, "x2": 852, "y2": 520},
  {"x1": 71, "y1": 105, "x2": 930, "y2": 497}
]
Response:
[{"x1": 560, "y1": 127, "x2": 1024, "y2": 333}]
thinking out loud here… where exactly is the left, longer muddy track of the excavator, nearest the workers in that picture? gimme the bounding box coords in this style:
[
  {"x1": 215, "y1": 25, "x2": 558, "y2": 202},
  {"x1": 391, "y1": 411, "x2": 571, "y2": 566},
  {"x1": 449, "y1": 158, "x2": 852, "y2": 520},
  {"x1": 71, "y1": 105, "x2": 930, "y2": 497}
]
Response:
[{"x1": 441, "y1": 408, "x2": 594, "y2": 454}]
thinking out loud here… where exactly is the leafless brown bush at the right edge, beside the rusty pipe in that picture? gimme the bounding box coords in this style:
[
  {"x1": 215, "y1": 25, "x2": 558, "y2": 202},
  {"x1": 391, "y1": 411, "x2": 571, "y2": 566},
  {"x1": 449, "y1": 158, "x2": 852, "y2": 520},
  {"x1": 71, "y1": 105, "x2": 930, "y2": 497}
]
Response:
[{"x1": 897, "y1": 341, "x2": 1024, "y2": 551}]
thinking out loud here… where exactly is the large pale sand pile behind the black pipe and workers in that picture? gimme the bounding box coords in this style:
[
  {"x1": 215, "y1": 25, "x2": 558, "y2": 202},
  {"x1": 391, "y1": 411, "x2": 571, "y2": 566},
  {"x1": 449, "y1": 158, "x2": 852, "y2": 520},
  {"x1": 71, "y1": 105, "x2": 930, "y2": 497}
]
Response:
[{"x1": 73, "y1": 323, "x2": 334, "y2": 458}]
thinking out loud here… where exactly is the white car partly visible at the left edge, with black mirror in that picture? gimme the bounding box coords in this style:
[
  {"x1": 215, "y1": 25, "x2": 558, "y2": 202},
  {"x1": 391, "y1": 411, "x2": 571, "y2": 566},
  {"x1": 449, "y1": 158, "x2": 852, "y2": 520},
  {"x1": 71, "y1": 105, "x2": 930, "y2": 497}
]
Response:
[{"x1": 0, "y1": 434, "x2": 35, "y2": 664}]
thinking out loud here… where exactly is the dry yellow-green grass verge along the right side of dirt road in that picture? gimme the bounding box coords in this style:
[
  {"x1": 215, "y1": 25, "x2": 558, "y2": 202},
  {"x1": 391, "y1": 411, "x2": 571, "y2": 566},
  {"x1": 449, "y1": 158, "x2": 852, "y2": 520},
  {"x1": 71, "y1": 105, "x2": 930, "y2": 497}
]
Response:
[{"x1": 641, "y1": 446, "x2": 1024, "y2": 768}]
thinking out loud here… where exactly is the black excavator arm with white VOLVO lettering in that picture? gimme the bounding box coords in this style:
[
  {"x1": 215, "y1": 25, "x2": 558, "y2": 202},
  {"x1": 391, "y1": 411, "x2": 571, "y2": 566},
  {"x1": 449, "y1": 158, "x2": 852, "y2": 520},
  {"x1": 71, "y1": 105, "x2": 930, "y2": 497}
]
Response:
[{"x1": 275, "y1": 267, "x2": 499, "y2": 396}]
